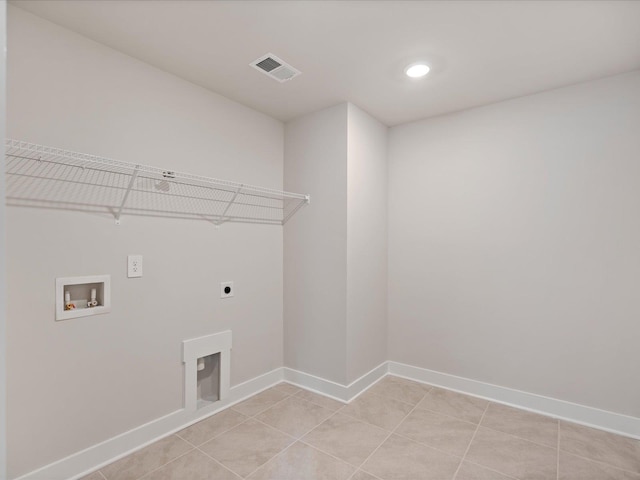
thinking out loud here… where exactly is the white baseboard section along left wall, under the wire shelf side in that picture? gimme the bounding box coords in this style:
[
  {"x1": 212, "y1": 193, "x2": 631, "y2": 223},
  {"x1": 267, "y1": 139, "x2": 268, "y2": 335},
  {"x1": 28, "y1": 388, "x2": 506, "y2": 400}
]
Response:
[{"x1": 15, "y1": 368, "x2": 283, "y2": 480}]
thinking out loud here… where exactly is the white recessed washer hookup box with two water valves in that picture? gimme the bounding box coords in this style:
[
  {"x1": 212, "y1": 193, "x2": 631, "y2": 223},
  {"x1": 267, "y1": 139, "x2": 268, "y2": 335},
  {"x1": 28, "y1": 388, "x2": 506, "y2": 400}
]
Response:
[{"x1": 56, "y1": 275, "x2": 111, "y2": 320}]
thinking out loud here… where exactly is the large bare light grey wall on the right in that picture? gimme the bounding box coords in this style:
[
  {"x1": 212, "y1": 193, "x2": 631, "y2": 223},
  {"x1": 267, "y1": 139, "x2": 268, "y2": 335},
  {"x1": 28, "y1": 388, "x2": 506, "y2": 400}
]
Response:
[{"x1": 389, "y1": 72, "x2": 640, "y2": 417}]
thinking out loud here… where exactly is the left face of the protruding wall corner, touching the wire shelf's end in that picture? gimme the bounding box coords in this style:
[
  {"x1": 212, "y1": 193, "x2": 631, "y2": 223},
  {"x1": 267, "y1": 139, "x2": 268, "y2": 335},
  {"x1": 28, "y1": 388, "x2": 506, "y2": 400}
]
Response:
[{"x1": 284, "y1": 103, "x2": 348, "y2": 383}]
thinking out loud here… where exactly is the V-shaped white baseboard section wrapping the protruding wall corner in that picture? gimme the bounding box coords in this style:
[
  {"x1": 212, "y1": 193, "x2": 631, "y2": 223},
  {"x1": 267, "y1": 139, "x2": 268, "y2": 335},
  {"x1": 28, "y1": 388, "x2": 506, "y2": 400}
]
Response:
[{"x1": 284, "y1": 362, "x2": 388, "y2": 403}]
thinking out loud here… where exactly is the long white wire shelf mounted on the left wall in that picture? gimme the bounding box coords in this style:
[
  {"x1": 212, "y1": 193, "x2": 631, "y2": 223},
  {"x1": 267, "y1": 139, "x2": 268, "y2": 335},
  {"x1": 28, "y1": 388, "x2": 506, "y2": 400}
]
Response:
[{"x1": 5, "y1": 139, "x2": 310, "y2": 225}]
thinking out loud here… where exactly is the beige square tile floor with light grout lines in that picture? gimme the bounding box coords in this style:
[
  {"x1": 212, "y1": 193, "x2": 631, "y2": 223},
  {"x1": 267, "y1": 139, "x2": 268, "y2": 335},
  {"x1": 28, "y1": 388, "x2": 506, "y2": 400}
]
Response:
[{"x1": 85, "y1": 376, "x2": 640, "y2": 480}]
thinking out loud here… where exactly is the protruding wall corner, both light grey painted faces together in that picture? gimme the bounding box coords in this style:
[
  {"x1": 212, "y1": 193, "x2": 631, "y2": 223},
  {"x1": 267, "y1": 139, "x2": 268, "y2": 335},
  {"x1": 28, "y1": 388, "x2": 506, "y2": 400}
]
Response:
[{"x1": 284, "y1": 103, "x2": 387, "y2": 385}]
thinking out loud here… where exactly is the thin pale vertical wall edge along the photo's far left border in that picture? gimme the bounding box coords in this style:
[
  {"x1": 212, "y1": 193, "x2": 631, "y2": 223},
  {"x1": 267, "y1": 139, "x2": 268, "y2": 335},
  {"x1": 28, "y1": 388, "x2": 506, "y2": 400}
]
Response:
[{"x1": 0, "y1": 0, "x2": 7, "y2": 480}]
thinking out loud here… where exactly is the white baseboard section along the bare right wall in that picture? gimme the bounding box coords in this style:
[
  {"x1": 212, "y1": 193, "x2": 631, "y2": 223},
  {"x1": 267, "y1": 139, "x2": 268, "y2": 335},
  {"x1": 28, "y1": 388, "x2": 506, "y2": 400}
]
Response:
[{"x1": 388, "y1": 361, "x2": 640, "y2": 439}]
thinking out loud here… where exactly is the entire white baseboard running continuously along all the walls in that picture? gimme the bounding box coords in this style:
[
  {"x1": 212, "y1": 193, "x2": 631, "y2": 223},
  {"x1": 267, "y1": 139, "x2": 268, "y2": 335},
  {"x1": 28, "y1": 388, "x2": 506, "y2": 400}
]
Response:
[{"x1": 15, "y1": 361, "x2": 640, "y2": 480}]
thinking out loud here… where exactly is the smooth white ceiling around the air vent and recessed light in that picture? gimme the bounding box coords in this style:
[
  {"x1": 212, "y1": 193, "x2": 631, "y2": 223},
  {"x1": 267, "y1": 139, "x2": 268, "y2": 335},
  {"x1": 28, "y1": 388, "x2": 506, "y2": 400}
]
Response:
[{"x1": 9, "y1": 0, "x2": 640, "y2": 125}]
